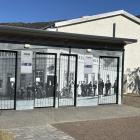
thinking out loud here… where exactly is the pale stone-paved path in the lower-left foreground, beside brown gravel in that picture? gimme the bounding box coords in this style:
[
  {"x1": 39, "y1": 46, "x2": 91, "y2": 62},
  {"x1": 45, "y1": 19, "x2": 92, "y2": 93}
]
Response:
[{"x1": 5, "y1": 124, "x2": 74, "y2": 140}]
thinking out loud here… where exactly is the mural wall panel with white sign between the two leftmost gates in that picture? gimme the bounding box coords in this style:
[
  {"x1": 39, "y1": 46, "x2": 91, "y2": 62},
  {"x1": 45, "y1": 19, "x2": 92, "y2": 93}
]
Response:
[{"x1": 16, "y1": 51, "x2": 35, "y2": 110}]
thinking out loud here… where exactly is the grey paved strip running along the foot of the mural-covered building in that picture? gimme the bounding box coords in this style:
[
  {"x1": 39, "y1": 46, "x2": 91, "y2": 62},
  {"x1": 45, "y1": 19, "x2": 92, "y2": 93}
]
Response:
[{"x1": 0, "y1": 105, "x2": 140, "y2": 128}]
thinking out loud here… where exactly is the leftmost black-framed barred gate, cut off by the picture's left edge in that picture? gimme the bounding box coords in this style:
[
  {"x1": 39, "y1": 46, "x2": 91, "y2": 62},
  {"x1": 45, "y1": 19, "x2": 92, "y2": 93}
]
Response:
[{"x1": 0, "y1": 50, "x2": 17, "y2": 109}]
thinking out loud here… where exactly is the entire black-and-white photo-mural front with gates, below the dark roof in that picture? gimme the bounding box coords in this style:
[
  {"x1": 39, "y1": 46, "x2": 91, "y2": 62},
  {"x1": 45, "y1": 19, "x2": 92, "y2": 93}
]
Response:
[{"x1": 0, "y1": 43, "x2": 122, "y2": 110}]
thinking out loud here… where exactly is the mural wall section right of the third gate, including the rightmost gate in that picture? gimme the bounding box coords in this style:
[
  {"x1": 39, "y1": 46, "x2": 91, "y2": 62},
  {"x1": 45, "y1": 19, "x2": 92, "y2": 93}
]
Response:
[{"x1": 71, "y1": 50, "x2": 122, "y2": 106}]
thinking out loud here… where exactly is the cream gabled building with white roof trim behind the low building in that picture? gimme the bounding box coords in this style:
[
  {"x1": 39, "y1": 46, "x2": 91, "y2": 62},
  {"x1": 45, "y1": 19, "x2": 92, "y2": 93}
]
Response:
[{"x1": 47, "y1": 10, "x2": 140, "y2": 94}]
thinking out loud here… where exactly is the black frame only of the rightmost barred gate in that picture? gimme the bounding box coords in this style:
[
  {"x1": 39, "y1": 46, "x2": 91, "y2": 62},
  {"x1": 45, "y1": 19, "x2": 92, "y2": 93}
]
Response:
[{"x1": 98, "y1": 56, "x2": 120, "y2": 105}]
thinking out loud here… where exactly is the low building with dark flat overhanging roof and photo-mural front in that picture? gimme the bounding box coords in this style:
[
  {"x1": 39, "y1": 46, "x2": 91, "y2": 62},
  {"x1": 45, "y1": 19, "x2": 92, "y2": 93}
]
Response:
[{"x1": 0, "y1": 26, "x2": 137, "y2": 110}]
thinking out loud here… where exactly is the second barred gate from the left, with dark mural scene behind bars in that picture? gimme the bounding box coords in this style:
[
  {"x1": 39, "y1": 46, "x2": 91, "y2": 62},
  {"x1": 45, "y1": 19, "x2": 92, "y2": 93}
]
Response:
[{"x1": 34, "y1": 53, "x2": 57, "y2": 107}]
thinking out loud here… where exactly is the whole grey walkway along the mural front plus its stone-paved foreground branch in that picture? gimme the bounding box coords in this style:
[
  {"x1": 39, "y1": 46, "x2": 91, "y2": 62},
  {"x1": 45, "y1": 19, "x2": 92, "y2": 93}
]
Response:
[{"x1": 0, "y1": 105, "x2": 140, "y2": 140}]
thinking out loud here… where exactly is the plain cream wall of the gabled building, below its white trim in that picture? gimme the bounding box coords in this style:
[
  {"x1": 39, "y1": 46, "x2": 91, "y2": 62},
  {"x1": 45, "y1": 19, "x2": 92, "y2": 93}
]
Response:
[{"x1": 55, "y1": 15, "x2": 140, "y2": 70}]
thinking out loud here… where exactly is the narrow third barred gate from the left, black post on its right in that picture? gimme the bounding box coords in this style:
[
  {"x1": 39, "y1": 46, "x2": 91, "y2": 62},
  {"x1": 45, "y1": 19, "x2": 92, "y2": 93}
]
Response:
[{"x1": 58, "y1": 54, "x2": 77, "y2": 106}]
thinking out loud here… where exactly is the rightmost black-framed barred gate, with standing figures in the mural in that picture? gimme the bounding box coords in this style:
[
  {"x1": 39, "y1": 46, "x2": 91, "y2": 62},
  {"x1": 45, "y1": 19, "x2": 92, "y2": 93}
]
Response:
[{"x1": 98, "y1": 56, "x2": 119, "y2": 104}]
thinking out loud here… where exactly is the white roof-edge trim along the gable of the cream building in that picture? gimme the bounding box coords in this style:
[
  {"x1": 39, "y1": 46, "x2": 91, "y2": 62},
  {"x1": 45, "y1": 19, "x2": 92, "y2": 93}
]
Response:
[{"x1": 55, "y1": 10, "x2": 140, "y2": 27}]
